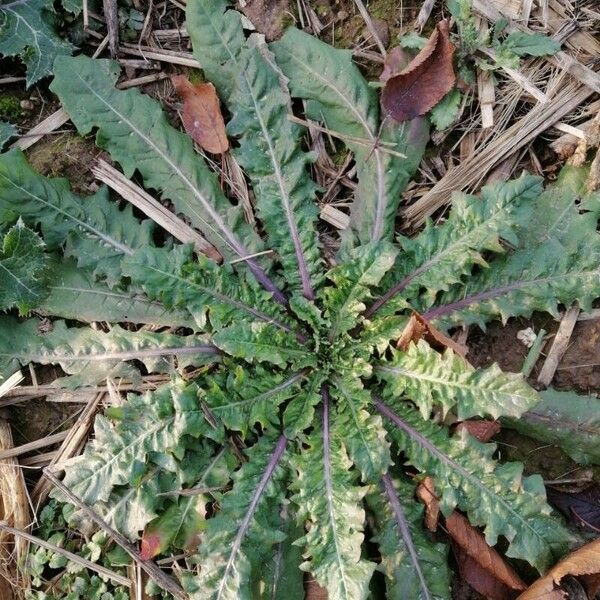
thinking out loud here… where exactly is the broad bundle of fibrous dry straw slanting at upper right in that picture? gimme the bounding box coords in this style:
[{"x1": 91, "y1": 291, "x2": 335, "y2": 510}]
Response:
[{"x1": 404, "y1": 75, "x2": 593, "y2": 227}]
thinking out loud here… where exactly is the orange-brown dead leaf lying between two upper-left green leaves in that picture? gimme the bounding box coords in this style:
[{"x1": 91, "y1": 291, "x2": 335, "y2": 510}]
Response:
[{"x1": 171, "y1": 75, "x2": 229, "y2": 154}]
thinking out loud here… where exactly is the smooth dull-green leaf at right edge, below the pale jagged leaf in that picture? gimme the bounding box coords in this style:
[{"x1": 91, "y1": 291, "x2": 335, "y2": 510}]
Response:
[{"x1": 502, "y1": 389, "x2": 600, "y2": 465}]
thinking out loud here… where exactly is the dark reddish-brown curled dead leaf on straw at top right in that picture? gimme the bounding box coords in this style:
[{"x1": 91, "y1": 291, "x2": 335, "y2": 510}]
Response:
[{"x1": 381, "y1": 20, "x2": 456, "y2": 122}]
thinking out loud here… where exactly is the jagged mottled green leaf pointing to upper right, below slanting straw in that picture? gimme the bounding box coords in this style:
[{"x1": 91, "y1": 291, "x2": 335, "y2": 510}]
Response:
[{"x1": 366, "y1": 175, "x2": 542, "y2": 317}]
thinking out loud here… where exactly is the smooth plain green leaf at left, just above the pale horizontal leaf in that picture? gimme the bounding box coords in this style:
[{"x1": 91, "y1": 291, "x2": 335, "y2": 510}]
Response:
[{"x1": 38, "y1": 260, "x2": 193, "y2": 327}]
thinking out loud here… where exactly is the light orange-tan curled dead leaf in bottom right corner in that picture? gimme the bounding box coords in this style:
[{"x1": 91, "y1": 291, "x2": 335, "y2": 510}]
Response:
[{"x1": 517, "y1": 538, "x2": 600, "y2": 600}]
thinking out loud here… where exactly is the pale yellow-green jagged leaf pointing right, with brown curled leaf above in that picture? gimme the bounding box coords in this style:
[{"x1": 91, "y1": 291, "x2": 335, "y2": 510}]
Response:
[{"x1": 377, "y1": 340, "x2": 539, "y2": 421}]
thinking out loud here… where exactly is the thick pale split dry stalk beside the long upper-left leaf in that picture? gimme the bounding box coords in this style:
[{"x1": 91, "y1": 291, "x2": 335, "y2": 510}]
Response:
[{"x1": 92, "y1": 159, "x2": 223, "y2": 261}]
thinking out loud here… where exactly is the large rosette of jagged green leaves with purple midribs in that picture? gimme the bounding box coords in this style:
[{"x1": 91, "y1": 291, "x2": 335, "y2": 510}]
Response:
[{"x1": 0, "y1": 0, "x2": 600, "y2": 600}]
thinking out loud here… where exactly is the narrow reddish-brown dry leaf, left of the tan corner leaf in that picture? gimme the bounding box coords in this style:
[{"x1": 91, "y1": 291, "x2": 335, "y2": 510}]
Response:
[{"x1": 446, "y1": 511, "x2": 527, "y2": 598}]
